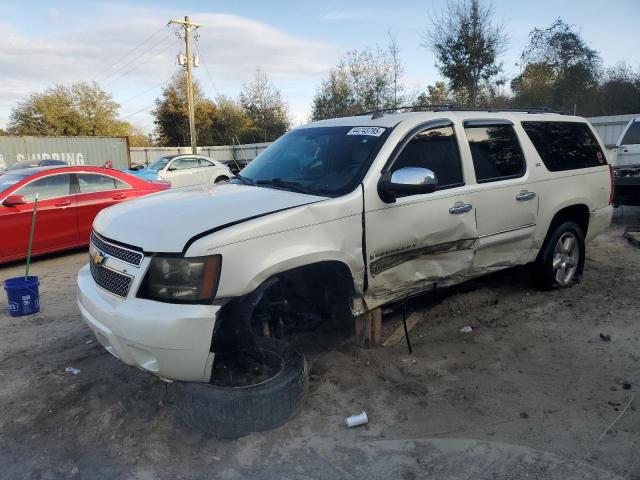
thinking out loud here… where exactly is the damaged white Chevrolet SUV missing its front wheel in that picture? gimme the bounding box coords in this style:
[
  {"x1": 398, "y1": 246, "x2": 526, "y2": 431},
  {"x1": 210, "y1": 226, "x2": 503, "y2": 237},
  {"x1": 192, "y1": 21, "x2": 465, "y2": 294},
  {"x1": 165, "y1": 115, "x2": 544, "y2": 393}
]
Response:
[{"x1": 78, "y1": 110, "x2": 612, "y2": 434}]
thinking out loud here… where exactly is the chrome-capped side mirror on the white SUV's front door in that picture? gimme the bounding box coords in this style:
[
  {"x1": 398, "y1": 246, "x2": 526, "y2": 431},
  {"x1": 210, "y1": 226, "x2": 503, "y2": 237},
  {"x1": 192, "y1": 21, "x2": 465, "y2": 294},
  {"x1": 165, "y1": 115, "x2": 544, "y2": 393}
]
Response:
[{"x1": 378, "y1": 167, "x2": 438, "y2": 203}]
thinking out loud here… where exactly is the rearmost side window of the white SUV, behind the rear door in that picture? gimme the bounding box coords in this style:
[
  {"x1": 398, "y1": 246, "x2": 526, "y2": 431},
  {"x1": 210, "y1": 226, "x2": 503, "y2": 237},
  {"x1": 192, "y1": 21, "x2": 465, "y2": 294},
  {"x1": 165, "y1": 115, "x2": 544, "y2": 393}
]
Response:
[{"x1": 522, "y1": 122, "x2": 607, "y2": 172}]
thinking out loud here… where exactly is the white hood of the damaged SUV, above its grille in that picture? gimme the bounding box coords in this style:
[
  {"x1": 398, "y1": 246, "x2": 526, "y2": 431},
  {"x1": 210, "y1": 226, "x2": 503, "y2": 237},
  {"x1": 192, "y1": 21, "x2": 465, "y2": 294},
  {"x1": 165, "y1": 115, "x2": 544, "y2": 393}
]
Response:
[{"x1": 93, "y1": 183, "x2": 326, "y2": 252}]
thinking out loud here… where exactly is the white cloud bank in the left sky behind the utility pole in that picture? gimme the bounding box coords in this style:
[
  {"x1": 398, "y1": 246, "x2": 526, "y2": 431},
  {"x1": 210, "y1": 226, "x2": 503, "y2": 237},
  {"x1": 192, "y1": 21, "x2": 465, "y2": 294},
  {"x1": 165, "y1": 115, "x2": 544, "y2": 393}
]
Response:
[{"x1": 0, "y1": 4, "x2": 340, "y2": 126}]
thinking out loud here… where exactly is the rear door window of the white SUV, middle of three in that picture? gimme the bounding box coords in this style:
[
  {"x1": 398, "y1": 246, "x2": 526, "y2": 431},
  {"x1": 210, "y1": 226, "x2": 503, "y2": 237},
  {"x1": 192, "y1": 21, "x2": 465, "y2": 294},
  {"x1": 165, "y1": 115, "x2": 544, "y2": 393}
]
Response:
[{"x1": 464, "y1": 125, "x2": 527, "y2": 183}]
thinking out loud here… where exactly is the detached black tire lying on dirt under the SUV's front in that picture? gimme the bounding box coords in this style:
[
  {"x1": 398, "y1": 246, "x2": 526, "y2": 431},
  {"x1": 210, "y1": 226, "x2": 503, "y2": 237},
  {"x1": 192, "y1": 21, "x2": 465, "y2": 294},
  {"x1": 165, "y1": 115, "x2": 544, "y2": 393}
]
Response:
[{"x1": 175, "y1": 337, "x2": 307, "y2": 438}]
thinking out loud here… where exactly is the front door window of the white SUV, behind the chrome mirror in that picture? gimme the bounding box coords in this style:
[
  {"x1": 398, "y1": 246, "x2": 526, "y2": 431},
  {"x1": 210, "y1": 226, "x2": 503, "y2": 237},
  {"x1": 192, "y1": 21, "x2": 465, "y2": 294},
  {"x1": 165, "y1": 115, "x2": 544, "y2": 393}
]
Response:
[{"x1": 391, "y1": 127, "x2": 464, "y2": 189}]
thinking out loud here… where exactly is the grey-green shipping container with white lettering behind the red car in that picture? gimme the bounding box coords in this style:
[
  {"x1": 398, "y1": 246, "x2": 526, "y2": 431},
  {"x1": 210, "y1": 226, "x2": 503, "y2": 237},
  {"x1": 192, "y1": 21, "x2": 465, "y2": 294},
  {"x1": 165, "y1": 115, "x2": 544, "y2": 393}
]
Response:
[{"x1": 0, "y1": 136, "x2": 129, "y2": 170}]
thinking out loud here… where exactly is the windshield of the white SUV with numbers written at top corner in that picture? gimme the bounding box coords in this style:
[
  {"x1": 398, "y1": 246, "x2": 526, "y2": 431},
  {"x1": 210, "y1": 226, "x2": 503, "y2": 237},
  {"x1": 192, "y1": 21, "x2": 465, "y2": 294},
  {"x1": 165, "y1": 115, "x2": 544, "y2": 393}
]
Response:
[{"x1": 239, "y1": 127, "x2": 389, "y2": 196}]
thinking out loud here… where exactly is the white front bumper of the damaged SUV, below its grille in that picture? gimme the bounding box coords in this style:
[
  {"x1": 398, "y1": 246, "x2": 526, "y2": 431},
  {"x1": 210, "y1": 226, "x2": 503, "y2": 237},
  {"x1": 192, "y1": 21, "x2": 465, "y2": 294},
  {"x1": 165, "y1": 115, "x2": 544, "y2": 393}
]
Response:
[{"x1": 78, "y1": 265, "x2": 221, "y2": 382}]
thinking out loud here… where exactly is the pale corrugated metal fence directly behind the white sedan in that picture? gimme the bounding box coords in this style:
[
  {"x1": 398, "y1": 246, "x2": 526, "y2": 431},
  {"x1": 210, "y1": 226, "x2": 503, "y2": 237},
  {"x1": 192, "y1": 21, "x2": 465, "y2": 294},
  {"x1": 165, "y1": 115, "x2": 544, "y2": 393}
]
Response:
[{"x1": 130, "y1": 143, "x2": 271, "y2": 165}]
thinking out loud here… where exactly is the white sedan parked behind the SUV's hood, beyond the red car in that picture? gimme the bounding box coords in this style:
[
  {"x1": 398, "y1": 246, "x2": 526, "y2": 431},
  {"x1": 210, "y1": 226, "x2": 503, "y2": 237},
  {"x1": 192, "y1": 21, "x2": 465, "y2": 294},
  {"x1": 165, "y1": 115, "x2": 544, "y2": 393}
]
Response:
[{"x1": 128, "y1": 155, "x2": 233, "y2": 187}]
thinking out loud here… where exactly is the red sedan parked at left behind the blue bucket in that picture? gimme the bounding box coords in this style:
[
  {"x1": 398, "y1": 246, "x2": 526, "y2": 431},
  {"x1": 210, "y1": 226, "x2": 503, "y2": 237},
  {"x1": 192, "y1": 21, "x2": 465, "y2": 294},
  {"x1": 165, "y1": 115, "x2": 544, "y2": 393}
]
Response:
[{"x1": 0, "y1": 166, "x2": 170, "y2": 263}]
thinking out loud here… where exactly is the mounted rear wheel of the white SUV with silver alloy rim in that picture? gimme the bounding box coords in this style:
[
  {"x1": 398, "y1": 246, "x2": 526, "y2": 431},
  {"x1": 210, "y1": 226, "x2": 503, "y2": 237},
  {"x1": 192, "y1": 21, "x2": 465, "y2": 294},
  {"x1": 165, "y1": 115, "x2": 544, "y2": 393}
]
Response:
[{"x1": 533, "y1": 222, "x2": 585, "y2": 290}]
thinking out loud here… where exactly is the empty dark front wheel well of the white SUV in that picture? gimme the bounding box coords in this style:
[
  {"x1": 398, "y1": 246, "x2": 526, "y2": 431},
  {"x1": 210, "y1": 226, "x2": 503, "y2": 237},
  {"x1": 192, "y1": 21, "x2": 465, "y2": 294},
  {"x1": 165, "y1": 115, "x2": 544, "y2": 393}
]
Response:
[{"x1": 211, "y1": 261, "x2": 356, "y2": 351}]
